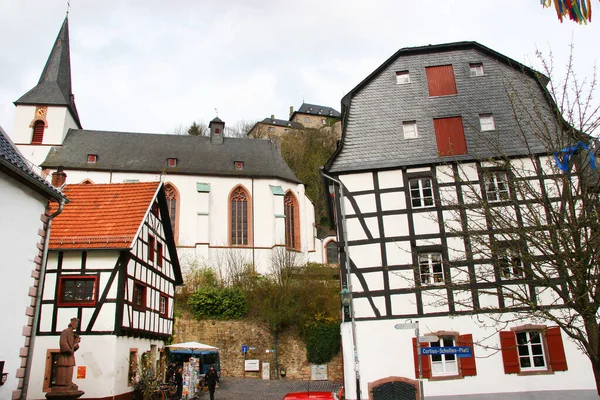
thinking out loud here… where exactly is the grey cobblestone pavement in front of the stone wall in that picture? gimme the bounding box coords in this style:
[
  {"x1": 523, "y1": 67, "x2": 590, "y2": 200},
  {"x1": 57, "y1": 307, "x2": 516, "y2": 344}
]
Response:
[{"x1": 193, "y1": 377, "x2": 342, "y2": 400}]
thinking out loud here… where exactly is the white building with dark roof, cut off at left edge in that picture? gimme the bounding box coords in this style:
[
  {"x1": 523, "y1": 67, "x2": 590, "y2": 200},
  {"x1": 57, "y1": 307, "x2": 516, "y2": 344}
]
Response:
[{"x1": 0, "y1": 127, "x2": 67, "y2": 399}]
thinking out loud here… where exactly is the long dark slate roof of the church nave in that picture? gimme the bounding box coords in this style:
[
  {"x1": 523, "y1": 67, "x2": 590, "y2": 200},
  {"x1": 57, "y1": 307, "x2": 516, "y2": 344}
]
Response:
[{"x1": 42, "y1": 129, "x2": 301, "y2": 183}]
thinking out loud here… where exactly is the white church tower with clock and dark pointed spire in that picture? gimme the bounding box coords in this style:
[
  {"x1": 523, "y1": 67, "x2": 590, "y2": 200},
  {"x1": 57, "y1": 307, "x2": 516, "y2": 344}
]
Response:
[{"x1": 11, "y1": 18, "x2": 81, "y2": 165}]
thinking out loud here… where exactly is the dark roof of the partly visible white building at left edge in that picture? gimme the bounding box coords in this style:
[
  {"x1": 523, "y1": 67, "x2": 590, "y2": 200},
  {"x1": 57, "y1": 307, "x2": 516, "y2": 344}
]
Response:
[{"x1": 0, "y1": 126, "x2": 66, "y2": 201}]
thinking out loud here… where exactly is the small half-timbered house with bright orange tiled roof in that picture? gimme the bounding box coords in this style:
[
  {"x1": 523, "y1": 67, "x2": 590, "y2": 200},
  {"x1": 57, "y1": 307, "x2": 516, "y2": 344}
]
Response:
[{"x1": 28, "y1": 182, "x2": 182, "y2": 399}]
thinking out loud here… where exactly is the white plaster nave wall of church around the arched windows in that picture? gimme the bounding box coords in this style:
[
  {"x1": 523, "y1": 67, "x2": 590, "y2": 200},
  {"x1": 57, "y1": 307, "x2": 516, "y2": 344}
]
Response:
[{"x1": 44, "y1": 170, "x2": 316, "y2": 273}]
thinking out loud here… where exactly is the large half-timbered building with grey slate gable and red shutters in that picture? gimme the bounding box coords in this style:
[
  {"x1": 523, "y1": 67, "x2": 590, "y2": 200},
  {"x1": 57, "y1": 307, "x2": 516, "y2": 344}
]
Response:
[{"x1": 323, "y1": 42, "x2": 597, "y2": 400}]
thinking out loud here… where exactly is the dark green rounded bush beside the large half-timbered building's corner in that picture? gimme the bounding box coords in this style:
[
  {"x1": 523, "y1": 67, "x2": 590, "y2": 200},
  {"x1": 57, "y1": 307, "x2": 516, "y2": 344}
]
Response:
[{"x1": 305, "y1": 322, "x2": 341, "y2": 364}]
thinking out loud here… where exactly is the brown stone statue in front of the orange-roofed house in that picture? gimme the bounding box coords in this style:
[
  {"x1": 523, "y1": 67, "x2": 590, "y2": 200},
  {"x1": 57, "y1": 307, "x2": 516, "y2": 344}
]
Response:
[{"x1": 52, "y1": 318, "x2": 81, "y2": 391}]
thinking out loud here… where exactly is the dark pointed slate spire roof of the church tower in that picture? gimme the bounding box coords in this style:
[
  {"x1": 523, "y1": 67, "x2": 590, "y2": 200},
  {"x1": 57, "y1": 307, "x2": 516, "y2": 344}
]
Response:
[{"x1": 15, "y1": 18, "x2": 81, "y2": 128}]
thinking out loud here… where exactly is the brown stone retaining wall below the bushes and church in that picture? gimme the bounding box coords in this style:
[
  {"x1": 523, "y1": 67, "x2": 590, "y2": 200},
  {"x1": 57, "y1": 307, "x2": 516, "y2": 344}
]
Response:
[{"x1": 173, "y1": 314, "x2": 343, "y2": 382}]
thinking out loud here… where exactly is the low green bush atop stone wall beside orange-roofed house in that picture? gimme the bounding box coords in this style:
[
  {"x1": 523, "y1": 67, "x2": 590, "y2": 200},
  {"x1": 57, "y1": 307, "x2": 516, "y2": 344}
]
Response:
[{"x1": 188, "y1": 287, "x2": 248, "y2": 319}]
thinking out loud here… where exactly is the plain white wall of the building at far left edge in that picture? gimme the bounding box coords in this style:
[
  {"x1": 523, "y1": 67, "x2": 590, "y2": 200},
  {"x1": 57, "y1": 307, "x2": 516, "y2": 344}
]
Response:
[{"x1": 0, "y1": 173, "x2": 46, "y2": 399}]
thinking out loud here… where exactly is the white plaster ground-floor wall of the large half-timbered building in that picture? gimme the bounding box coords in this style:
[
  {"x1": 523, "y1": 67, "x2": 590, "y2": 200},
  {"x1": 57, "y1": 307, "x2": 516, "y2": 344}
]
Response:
[{"x1": 341, "y1": 316, "x2": 595, "y2": 399}]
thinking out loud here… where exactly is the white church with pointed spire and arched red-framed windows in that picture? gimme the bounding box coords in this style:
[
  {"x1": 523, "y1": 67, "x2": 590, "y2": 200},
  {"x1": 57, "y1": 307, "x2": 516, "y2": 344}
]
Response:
[{"x1": 11, "y1": 19, "x2": 322, "y2": 273}]
